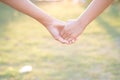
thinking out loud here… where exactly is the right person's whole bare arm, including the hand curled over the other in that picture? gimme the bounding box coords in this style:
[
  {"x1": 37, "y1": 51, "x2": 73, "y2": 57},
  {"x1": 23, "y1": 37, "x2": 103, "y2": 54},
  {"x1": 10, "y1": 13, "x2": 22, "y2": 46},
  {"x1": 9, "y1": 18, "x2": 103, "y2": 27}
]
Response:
[{"x1": 61, "y1": 0, "x2": 114, "y2": 44}]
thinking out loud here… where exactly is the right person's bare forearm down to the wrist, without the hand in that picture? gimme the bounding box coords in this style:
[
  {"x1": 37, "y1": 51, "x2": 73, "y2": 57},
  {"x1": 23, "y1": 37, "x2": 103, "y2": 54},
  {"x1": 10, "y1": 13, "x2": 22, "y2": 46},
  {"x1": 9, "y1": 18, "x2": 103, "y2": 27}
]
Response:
[{"x1": 78, "y1": 0, "x2": 113, "y2": 26}]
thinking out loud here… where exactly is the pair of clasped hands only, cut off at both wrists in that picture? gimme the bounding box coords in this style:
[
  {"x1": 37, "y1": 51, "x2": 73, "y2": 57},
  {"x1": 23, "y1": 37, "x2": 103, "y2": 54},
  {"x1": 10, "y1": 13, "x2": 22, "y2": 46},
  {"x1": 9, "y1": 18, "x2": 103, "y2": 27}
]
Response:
[{"x1": 46, "y1": 20, "x2": 84, "y2": 44}]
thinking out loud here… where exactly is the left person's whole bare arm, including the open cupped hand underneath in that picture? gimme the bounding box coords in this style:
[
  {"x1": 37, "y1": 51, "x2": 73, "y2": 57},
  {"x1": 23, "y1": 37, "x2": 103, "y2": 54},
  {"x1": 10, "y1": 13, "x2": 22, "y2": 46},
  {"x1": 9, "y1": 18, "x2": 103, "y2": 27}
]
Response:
[{"x1": 0, "y1": 0, "x2": 67, "y2": 43}]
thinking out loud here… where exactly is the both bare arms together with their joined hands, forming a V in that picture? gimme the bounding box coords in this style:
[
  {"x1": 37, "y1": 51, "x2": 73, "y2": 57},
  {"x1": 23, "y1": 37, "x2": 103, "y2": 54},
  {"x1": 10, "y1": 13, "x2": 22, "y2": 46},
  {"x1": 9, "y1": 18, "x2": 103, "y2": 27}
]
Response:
[{"x1": 0, "y1": 0, "x2": 114, "y2": 44}]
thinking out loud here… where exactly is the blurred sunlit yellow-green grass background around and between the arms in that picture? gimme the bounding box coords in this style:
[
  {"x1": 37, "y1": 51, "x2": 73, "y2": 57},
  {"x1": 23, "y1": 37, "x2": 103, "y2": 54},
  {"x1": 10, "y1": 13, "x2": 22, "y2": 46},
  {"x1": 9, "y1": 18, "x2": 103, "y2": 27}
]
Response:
[{"x1": 0, "y1": 0, "x2": 120, "y2": 80}]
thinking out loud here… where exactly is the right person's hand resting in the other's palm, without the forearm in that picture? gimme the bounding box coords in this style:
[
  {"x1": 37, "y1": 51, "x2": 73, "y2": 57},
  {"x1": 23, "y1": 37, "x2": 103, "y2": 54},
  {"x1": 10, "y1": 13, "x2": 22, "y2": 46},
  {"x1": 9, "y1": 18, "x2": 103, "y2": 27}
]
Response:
[{"x1": 61, "y1": 20, "x2": 84, "y2": 44}]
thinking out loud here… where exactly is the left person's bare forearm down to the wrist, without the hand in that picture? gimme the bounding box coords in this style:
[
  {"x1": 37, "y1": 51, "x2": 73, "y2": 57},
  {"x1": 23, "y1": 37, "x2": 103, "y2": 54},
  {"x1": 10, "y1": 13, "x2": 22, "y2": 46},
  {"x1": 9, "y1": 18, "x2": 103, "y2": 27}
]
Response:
[{"x1": 1, "y1": 0, "x2": 54, "y2": 26}]
